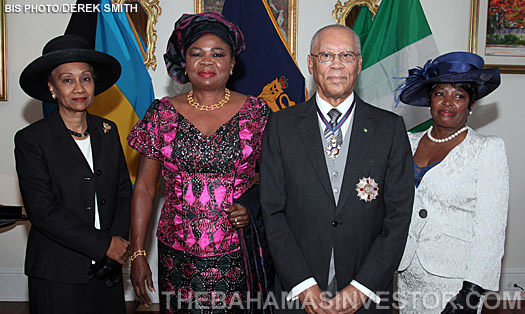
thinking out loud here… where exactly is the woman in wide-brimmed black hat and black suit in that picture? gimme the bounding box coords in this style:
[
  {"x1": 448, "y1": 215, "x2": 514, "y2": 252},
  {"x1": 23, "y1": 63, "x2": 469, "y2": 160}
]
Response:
[{"x1": 15, "y1": 35, "x2": 131, "y2": 314}]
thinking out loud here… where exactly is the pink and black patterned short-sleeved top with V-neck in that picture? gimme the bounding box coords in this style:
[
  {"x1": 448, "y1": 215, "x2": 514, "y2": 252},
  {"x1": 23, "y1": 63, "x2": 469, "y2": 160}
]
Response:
[{"x1": 127, "y1": 96, "x2": 270, "y2": 257}]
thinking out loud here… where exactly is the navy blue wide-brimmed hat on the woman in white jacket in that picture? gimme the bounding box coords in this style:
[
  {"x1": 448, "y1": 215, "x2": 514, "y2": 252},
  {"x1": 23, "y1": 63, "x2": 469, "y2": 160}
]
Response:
[{"x1": 396, "y1": 51, "x2": 501, "y2": 107}]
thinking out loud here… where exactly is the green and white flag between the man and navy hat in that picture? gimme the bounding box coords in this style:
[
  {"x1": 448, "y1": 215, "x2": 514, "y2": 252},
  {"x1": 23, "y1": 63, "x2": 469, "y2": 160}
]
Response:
[{"x1": 353, "y1": 0, "x2": 439, "y2": 130}]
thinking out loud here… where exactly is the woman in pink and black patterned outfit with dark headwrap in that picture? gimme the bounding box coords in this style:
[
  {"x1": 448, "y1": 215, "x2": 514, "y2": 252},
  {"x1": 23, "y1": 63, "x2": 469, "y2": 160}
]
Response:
[{"x1": 128, "y1": 12, "x2": 269, "y2": 313}]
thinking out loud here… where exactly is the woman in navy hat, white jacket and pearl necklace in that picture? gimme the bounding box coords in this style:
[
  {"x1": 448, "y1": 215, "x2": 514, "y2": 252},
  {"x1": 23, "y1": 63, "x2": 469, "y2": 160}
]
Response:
[{"x1": 398, "y1": 52, "x2": 509, "y2": 314}]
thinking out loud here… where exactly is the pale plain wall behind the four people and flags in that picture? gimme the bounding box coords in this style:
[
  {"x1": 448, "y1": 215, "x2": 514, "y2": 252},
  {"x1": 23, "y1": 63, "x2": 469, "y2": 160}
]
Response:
[{"x1": 0, "y1": 0, "x2": 525, "y2": 300}]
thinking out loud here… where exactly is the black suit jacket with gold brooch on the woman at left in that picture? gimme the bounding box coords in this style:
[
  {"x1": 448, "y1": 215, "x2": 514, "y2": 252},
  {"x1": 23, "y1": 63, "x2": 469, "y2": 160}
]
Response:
[{"x1": 15, "y1": 110, "x2": 131, "y2": 283}]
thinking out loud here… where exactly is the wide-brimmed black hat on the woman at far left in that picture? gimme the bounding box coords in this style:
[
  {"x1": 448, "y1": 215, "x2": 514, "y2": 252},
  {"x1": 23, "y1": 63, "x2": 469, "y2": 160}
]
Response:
[{"x1": 20, "y1": 35, "x2": 122, "y2": 102}]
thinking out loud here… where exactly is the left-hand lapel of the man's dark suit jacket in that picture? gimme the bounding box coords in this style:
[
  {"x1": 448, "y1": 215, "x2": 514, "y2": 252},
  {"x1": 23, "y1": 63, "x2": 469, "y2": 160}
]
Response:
[{"x1": 296, "y1": 94, "x2": 335, "y2": 204}]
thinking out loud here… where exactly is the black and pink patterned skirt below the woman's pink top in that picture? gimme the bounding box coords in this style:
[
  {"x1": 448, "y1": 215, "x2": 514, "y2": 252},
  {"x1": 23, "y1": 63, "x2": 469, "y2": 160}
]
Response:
[{"x1": 158, "y1": 241, "x2": 246, "y2": 314}]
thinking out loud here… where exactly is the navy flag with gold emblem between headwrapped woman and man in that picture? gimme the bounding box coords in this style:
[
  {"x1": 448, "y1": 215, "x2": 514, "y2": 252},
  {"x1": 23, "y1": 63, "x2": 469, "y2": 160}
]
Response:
[{"x1": 222, "y1": 0, "x2": 306, "y2": 111}]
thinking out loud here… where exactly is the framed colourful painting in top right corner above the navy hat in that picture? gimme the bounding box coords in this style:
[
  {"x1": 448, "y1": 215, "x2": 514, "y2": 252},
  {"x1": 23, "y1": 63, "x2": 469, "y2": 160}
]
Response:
[{"x1": 469, "y1": 0, "x2": 525, "y2": 74}]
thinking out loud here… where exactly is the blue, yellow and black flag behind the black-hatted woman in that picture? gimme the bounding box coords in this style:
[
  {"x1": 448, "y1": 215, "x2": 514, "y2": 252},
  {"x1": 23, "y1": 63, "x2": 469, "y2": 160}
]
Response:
[{"x1": 44, "y1": 0, "x2": 155, "y2": 182}]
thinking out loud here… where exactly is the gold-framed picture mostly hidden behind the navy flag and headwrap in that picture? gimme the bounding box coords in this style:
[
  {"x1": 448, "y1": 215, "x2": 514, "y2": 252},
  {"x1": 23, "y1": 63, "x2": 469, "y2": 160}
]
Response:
[{"x1": 195, "y1": 0, "x2": 298, "y2": 56}]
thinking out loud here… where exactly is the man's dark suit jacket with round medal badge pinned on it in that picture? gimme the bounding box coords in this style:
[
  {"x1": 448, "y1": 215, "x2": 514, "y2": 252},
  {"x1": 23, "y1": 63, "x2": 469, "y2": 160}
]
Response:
[{"x1": 260, "y1": 95, "x2": 414, "y2": 312}]
